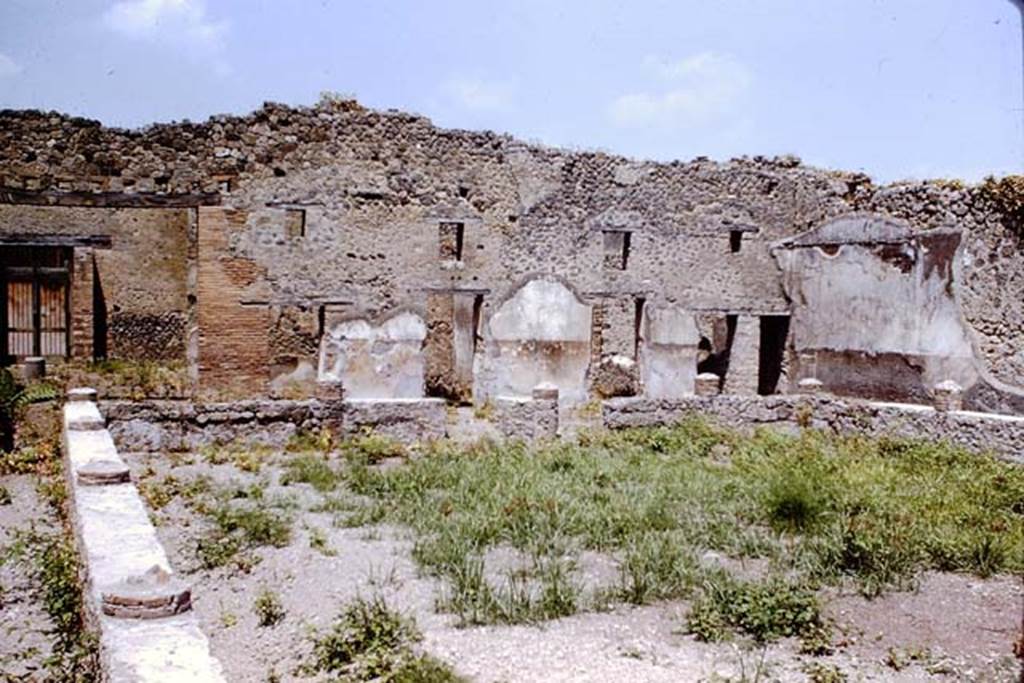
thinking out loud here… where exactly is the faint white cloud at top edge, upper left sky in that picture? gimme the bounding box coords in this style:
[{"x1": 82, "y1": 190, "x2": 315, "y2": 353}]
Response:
[{"x1": 103, "y1": 0, "x2": 229, "y2": 75}]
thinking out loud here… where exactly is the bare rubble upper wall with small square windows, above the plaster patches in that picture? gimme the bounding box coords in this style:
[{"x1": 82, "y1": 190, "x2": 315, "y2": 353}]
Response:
[{"x1": 0, "y1": 101, "x2": 1024, "y2": 397}]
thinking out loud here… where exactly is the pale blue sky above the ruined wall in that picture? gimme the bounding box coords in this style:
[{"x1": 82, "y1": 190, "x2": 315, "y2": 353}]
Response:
[{"x1": 0, "y1": 0, "x2": 1024, "y2": 181}]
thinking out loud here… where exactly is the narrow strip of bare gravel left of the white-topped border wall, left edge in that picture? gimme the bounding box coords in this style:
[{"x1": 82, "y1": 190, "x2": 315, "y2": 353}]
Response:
[{"x1": 0, "y1": 474, "x2": 60, "y2": 681}]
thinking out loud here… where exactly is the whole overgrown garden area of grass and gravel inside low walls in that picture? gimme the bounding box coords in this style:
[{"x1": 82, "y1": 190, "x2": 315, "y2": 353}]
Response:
[{"x1": 123, "y1": 418, "x2": 1024, "y2": 681}]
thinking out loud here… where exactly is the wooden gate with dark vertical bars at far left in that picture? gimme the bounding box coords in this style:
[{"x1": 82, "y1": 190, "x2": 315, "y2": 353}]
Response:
[{"x1": 0, "y1": 246, "x2": 72, "y2": 359}]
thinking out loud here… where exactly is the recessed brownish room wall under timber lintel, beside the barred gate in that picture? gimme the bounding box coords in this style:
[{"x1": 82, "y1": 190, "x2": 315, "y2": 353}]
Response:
[{"x1": 0, "y1": 204, "x2": 188, "y2": 360}]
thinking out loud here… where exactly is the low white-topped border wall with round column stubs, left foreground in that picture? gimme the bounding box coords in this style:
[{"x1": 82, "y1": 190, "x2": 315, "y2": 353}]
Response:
[{"x1": 62, "y1": 390, "x2": 225, "y2": 683}]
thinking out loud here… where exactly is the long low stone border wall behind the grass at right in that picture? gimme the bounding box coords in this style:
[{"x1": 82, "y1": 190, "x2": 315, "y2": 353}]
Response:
[{"x1": 601, "y1": 394, "x2": 1024, "y2": 463}]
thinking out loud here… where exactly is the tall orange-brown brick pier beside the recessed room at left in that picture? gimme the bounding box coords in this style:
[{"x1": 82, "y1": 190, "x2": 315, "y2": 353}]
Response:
[{"x1": 197, "y1": 208, "x2": 270, "y2": 394}]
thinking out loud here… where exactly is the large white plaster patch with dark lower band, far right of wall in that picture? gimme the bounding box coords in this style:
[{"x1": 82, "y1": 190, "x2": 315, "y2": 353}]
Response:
[{"x1": 775, "y1": 215, "x2": 978, "y2": 401}]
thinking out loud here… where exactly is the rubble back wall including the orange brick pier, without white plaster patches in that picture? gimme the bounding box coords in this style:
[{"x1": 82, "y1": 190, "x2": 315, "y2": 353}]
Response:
[{"x1": 0, "y1": 101, "x2": 1024, "y2": 398}]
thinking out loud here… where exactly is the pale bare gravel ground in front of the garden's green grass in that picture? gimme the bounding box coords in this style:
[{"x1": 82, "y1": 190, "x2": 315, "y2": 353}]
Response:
[{"x1": 126, "y1": 454, "x2": 1022, "y2": 683}]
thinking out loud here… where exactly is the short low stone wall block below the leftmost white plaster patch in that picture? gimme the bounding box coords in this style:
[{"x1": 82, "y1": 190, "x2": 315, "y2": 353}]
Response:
[{"x1": 341, "y1": 398, "x2": 447, "y2": 443}]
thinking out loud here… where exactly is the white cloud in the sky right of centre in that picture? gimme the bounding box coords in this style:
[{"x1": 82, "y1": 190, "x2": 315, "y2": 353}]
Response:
[{"x1": 608, "y1": 52, "x2": 751, "y2": 126}]
